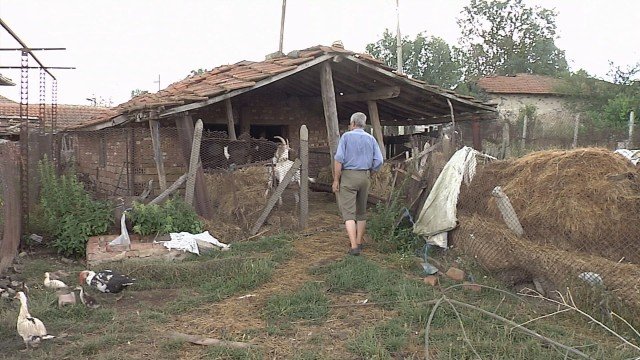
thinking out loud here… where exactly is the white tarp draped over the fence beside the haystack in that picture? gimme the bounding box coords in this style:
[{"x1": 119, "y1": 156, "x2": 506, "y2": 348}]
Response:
[{"x1": 413, "y1": 146, "x2": 482, "y2": 248}]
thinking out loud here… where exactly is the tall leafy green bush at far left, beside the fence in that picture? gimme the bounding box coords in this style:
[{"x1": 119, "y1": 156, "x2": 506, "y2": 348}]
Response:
[{"x1": 38, "y1": 157, "x2": 113, "y2": 257}]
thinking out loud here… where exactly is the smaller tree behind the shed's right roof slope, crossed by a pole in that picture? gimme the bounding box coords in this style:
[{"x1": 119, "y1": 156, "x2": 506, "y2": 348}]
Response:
[{"x1": 366, "y1": 29, "x2": 462, "y2": 89}]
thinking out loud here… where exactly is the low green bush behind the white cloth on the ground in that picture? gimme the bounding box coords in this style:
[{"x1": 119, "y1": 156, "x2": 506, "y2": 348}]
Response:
[{"x1": 129, "y1": 198, "x2": 204, "y2": 235}]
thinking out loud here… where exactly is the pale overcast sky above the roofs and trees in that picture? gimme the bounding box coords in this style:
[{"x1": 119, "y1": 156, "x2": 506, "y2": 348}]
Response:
[{"x1": 0, "y1": 0, "x2": 640, "y2": 105}]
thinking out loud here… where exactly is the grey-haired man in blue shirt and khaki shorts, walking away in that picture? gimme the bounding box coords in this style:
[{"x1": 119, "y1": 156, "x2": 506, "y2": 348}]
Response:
[{"x1": 333, "y1": 112, "x2": 383, "y2": 255}]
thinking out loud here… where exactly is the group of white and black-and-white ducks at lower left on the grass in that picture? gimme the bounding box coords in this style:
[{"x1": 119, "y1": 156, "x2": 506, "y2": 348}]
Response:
[{"x1": 15, "y1": 270, "x2": 135, "y2": 349}]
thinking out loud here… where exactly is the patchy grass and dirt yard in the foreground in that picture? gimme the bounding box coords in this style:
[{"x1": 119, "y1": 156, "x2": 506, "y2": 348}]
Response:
[{"x1": 0, "y1": 210, "x2": 640, "y2": 359}]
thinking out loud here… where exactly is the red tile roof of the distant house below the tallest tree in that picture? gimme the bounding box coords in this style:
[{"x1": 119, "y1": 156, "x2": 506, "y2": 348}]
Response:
[{"x1": 478, "y1": 74, "x2": 562, "y2": 95}]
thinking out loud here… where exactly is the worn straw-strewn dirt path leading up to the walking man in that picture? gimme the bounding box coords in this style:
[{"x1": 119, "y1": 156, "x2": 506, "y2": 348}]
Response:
[{"x1": 167, "y1": 193, "x2": 396, "y2": 359}]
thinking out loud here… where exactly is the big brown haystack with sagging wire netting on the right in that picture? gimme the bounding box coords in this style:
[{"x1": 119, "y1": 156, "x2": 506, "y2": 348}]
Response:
[{"x1": 452, "y1": 148, "x2": 640, "y2": 309}]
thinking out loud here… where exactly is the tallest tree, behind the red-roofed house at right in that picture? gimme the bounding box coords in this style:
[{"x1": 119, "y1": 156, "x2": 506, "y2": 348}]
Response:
[{"x1": 458, "y1": 0, "x2": 568, "y2": 81}]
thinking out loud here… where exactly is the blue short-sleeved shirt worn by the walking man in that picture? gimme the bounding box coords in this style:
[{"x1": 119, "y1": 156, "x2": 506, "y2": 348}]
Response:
[{"x1": 334, "y1": 129, "x2": 383, "y2": 171}]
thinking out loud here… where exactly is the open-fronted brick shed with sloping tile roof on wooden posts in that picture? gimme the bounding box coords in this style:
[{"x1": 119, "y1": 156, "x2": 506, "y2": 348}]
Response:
[{"x1": 65, "y1": 46, "x2": 496, "y2": 219}]
